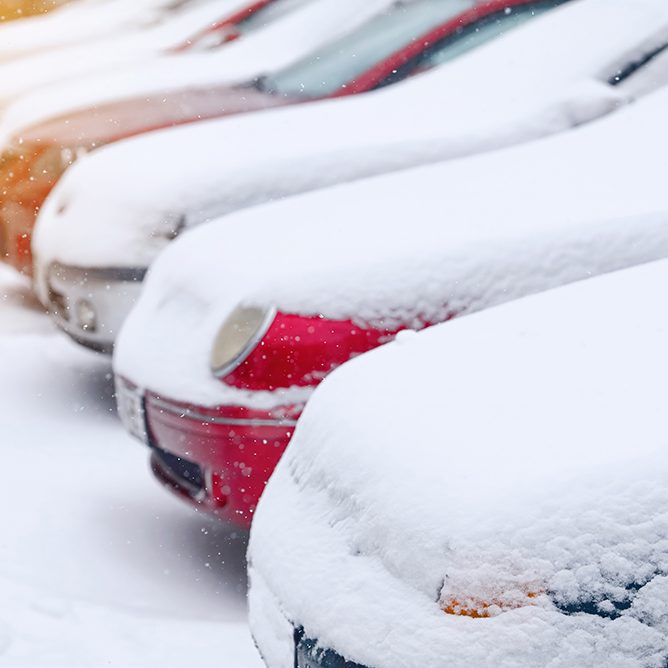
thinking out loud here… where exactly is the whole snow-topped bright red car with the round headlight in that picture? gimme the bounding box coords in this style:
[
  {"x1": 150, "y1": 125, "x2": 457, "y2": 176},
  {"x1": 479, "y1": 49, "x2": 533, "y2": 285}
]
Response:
[{"x1": 114, "y1": 82, "x2": 668, "y2": 524}]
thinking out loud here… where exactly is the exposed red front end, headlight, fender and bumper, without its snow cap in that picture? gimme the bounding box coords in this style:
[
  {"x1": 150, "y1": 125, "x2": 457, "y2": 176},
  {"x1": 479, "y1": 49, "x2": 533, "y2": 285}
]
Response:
[{"x1": 116, "y1": 306, "x2": 400, "y2": 527}]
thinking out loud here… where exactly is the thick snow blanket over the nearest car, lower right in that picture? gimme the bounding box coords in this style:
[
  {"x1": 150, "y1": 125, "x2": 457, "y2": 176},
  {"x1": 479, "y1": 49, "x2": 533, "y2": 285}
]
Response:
[{"x1": 249, "y1": 261, "x2": 668, "y2": 668}]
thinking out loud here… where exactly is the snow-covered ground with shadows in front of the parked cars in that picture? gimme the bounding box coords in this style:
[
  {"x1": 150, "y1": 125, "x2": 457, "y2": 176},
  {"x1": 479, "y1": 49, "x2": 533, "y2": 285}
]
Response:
[{"x1": 0, "y1": 267, "x2": 262, "y2": 668}]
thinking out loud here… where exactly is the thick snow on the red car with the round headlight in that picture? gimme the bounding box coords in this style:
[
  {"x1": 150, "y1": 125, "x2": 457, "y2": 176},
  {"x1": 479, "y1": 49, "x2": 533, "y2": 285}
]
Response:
[{"x1": 115, "y1": 89, "x2": 668, "y2": 405}]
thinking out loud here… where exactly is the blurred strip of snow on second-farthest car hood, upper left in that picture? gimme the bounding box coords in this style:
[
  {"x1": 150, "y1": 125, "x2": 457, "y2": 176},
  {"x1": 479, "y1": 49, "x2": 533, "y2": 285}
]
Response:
[{"x1": 0, "y1": 0, "x2": 254, "y2": 112}]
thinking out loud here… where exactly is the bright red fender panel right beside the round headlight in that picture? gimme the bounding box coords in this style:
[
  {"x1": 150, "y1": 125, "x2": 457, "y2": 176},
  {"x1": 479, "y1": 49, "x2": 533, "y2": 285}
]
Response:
[{"x1": 223, "y1": 312, "x2": 399, "y2": 391}]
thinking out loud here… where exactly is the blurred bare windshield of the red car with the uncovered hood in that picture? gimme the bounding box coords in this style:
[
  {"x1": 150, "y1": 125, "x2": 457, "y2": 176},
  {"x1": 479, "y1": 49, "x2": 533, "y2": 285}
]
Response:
[{"x1": 261, "y1": 0, "x2": 474, "y2": 97}]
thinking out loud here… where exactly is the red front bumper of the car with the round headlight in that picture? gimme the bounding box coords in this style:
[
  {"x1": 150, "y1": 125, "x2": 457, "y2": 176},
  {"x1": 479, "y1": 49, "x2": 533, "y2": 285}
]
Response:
[{"x1": 117, "y1": 380, "x2": 302, "y2": 527}]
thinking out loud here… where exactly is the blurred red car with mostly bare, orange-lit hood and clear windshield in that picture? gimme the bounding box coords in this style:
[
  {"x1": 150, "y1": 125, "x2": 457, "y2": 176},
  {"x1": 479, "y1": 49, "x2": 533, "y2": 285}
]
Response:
[{"x1": 0, "y1": 0, "x2": 567, "y2": 273}]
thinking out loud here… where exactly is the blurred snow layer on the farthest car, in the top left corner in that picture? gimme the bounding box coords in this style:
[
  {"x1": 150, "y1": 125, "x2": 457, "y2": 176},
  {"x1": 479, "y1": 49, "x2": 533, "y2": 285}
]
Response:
[{"x1": 0, "y1": 0, "x2": 190, "y2": 62}]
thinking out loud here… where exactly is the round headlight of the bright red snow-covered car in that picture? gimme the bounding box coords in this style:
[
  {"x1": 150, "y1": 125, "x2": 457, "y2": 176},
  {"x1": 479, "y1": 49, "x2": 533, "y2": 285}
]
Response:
[{"x1": 210, "y1": 306, "x2": 275, "y2": 377}]
